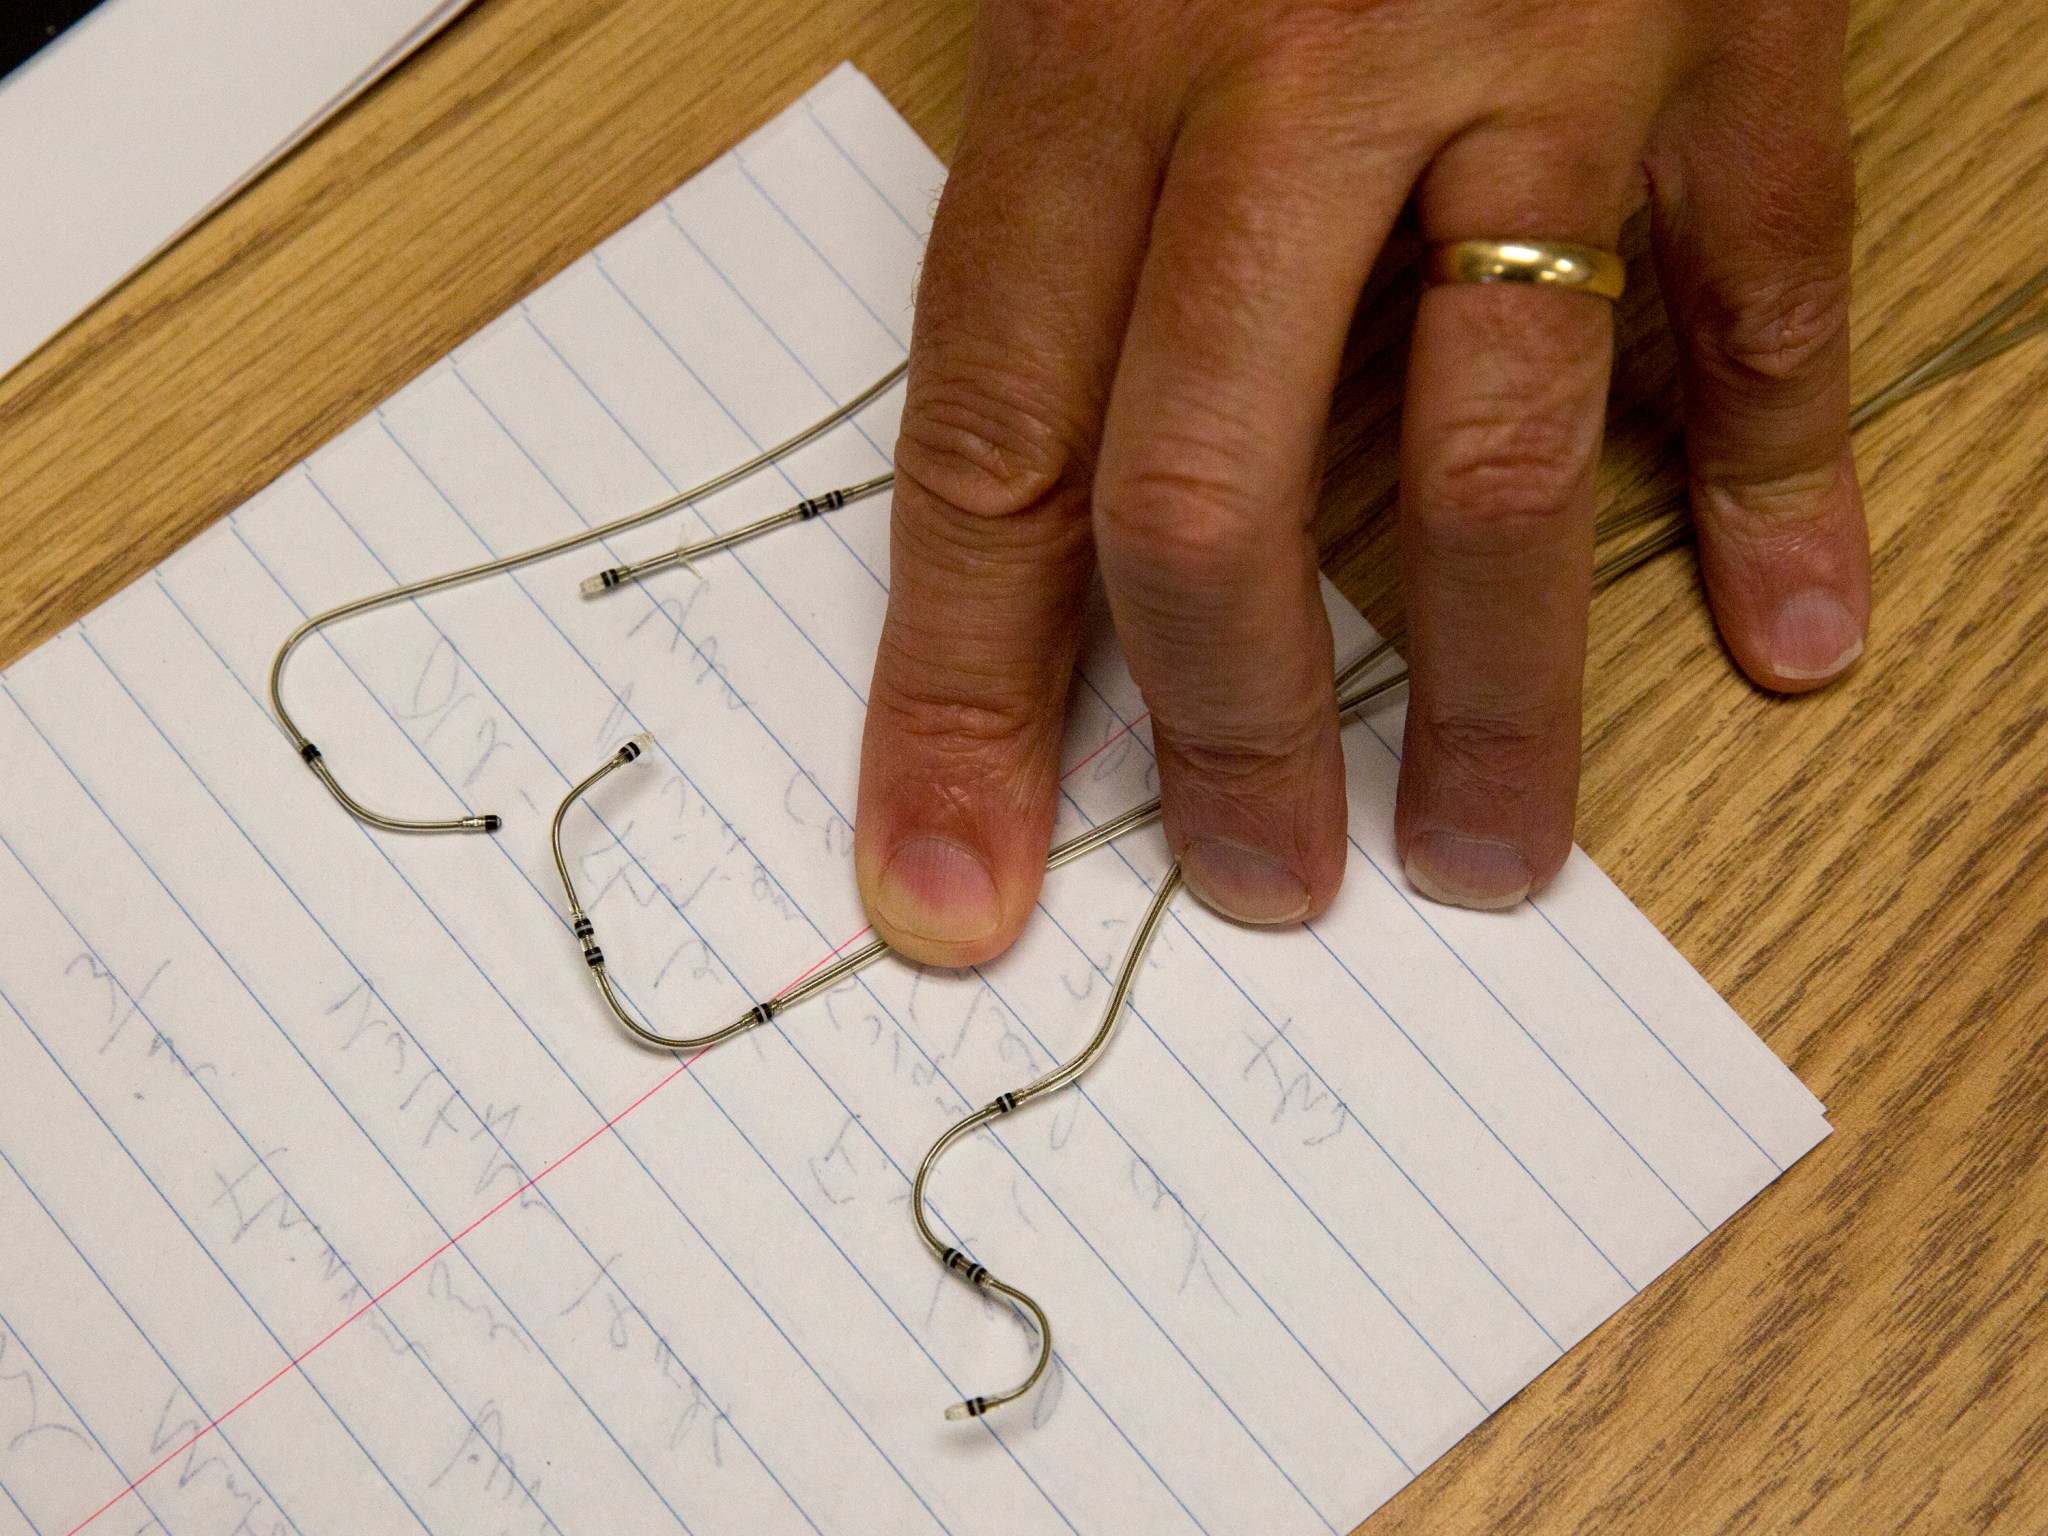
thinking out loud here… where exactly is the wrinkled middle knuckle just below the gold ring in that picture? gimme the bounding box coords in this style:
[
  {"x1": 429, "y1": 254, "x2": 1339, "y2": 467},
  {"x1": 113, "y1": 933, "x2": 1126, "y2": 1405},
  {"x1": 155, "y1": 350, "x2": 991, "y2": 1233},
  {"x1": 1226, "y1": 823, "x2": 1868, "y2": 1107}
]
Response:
[{"x1": 1421, "y1": 410, "x2": 1591, "y2": 526}]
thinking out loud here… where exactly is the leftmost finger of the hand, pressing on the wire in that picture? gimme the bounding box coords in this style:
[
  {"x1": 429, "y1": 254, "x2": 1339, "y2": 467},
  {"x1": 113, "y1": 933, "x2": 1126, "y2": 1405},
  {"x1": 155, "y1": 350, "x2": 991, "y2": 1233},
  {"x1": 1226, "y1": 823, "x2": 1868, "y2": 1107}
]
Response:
[{"x1": 854, "y1": 75, "x2": 1155, "y2": 965}]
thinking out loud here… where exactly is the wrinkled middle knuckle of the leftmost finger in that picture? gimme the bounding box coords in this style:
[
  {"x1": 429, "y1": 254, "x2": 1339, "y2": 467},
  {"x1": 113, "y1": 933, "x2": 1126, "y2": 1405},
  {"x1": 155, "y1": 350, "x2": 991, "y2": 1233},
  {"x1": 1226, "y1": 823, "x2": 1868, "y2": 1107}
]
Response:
[{"x1": 895, "y1": 362, "x2": 1075, "y2": 518}]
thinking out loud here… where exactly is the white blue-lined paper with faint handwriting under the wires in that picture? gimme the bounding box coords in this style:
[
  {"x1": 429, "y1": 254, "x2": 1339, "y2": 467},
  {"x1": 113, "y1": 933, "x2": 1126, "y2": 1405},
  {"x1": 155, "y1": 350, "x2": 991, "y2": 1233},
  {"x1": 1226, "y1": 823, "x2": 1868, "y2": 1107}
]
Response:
[{"x1": 0, "y1": 68, "x2": 1827, "y2": 1536}]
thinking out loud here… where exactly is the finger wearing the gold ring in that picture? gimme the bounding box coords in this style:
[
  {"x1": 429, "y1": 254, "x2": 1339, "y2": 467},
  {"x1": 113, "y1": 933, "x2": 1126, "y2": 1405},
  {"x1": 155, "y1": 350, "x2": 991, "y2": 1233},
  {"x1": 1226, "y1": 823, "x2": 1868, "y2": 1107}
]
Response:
[{"x1": 1395, "y1": 127, "x2": 1640, "y2": 907}]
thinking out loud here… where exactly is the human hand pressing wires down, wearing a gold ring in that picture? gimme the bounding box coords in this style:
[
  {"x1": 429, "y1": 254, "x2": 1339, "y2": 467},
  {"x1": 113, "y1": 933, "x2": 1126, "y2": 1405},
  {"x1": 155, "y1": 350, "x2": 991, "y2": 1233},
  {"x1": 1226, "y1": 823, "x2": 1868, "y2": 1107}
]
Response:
[{"x1": 856, "y1": 0, "x2": 1870, "y2": 965}]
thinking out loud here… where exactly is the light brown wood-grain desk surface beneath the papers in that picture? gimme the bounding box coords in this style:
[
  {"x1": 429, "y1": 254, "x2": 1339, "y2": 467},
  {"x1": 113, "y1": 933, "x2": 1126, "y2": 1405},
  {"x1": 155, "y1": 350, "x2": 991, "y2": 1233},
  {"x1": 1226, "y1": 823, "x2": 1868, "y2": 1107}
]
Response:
[{"x1": 0, "y1": 0, "x2": 2048, "y2": 1536}]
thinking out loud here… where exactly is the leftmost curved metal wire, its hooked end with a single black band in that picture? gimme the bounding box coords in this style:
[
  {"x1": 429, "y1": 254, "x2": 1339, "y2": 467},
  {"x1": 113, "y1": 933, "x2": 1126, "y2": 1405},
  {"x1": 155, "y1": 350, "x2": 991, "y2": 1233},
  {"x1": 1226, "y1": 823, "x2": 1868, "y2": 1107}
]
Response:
[{"x1": 270, "y1": 362, "x2": 905, "y2": 831}]
